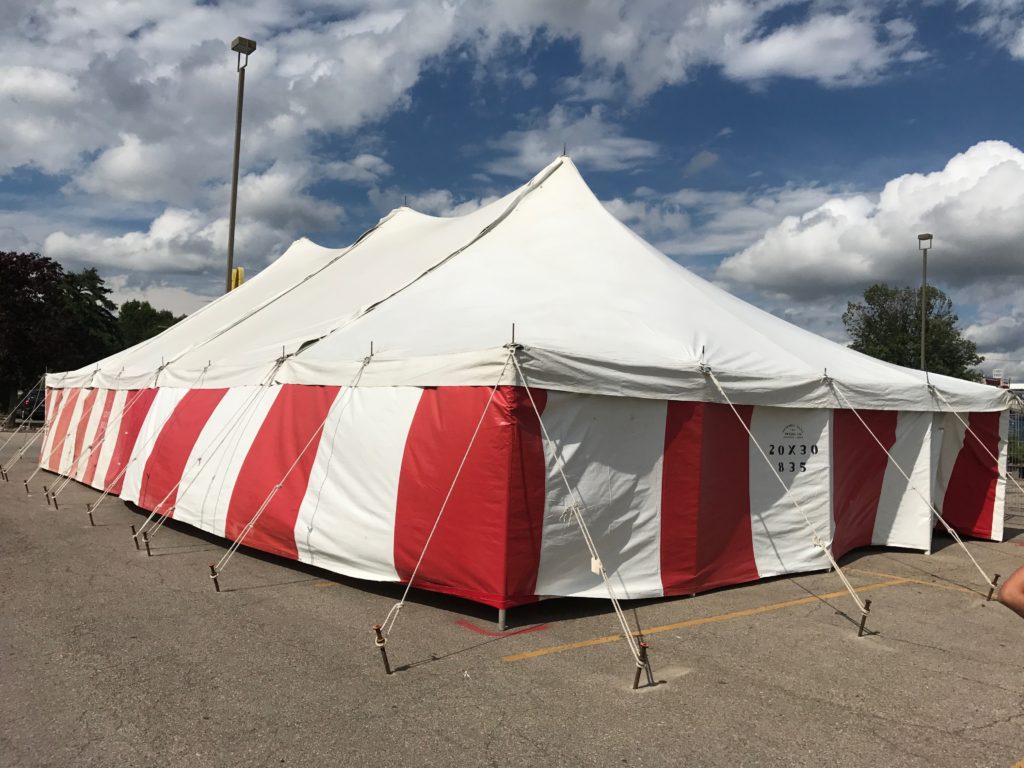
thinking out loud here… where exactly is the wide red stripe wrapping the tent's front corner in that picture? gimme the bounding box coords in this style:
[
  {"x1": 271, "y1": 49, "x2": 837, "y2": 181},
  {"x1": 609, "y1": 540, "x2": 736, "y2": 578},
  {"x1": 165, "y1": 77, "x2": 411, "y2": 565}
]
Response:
[{"x1": 394, "y1": 387, "x2": 547, "y2": 608}]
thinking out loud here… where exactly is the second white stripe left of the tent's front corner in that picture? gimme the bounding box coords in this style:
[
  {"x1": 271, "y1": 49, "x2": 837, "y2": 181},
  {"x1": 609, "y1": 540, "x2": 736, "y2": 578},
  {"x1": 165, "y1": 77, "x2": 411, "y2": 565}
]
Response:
[{"x1": 174, "y1": 386, "x2": 281, "y2": 536}]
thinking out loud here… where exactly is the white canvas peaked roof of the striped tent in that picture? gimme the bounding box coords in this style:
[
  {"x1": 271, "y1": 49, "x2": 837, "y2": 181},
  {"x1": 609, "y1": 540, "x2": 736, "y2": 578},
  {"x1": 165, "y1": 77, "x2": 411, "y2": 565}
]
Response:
[{"x1": 48, "y1": 158, "x2": 1011, "y2": 421}]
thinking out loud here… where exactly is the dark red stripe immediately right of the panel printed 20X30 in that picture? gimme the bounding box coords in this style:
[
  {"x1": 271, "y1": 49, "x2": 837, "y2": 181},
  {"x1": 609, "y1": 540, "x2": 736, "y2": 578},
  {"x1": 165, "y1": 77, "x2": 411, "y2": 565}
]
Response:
[{"x1": 831, "y1": 411, "x2": 899, "y2": 557}]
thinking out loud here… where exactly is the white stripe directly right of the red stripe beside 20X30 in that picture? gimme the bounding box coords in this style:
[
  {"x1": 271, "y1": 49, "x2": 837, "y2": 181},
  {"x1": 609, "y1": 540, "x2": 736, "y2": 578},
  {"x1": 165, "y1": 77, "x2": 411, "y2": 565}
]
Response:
[{"x1": 871, "y1": 412, "x2": 935, "y2": 552}]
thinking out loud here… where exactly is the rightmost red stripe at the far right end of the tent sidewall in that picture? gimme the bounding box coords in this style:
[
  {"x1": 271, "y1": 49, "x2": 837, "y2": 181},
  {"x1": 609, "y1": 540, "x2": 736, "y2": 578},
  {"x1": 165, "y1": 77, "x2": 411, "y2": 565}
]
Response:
[{"x1": 942, "y1": 411, "x2": 1002, "y2": 539}]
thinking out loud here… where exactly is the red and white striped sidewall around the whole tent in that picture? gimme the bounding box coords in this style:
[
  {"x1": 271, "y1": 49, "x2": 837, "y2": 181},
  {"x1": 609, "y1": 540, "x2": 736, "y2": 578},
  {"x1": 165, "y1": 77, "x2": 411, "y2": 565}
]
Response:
[{"x1": 41, "y1": 385, "x2": 1008, "y2": 607}]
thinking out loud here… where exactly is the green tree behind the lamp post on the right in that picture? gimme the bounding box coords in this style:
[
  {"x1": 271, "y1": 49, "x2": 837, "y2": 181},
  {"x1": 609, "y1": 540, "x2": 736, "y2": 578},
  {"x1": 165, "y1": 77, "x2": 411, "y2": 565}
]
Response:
[{"x1": 843, "y1": 283, "x2": 985, "y2": 380}]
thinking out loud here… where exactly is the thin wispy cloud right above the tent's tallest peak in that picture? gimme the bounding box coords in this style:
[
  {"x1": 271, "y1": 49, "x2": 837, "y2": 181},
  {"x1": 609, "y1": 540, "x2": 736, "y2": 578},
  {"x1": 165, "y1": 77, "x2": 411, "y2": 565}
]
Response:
[{"x1": 486, "y1": 105, "x2": 657, "y2": 177}]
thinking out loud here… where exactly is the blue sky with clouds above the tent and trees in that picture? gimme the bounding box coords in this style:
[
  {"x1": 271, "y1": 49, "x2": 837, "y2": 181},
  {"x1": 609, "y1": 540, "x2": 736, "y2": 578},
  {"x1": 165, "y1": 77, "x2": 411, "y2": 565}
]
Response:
[{"x1": 0, "y1": 0, "x2": 1024, "y2": 378}]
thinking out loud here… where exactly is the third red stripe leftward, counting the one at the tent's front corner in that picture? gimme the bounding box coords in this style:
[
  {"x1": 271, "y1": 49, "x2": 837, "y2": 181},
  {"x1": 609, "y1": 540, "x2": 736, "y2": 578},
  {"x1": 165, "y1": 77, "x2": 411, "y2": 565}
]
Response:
[{"x1": 138, "y1": 389, "x2": 227, "y2": 516}]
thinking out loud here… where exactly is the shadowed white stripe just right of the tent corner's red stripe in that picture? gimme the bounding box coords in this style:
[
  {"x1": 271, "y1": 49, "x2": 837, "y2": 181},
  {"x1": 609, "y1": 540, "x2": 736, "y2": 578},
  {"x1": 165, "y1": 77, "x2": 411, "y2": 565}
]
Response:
[{"x1": 537, "y1": 392, "x2": 667, "y2": 599}]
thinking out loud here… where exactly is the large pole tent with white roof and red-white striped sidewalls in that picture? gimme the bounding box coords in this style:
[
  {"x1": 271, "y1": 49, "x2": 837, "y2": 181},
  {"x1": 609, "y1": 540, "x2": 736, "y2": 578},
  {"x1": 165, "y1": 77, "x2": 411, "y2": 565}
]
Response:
[{"x1": 40, "y1": 157, "x2": 1011, "y2": 608}]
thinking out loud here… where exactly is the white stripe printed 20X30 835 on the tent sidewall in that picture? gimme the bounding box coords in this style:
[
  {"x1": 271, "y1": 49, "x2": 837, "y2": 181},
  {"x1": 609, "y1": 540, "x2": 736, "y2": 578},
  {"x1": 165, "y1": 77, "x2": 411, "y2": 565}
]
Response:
[{"x1": 748, "y1": 407, "x2": 835, "y2": 578}]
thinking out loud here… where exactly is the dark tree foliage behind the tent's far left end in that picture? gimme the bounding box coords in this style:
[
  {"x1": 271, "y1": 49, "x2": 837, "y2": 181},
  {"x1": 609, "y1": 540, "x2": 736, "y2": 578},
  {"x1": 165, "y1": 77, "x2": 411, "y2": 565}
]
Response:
[{"x1": 0, "y1": 251, "x2": 186, "y2": 406}]
